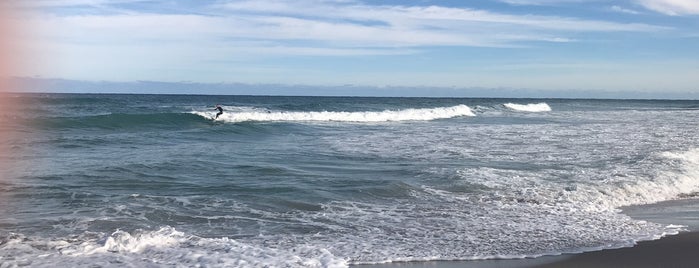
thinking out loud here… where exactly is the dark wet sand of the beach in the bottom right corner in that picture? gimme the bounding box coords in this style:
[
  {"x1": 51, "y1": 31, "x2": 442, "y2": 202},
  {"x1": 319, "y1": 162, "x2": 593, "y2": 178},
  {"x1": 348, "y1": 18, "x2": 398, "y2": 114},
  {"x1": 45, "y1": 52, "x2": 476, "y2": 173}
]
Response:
[{"x1": 352, "y1": 198, "x2": 699, "y2": 268}]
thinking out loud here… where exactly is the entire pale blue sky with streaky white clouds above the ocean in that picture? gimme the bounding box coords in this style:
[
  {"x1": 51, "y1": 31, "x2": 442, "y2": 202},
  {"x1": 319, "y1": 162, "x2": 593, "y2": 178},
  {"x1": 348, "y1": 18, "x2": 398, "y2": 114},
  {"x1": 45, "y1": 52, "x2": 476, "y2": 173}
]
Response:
[{"x1": 8, "y1": 0, "x2": 699, "y2": 96}]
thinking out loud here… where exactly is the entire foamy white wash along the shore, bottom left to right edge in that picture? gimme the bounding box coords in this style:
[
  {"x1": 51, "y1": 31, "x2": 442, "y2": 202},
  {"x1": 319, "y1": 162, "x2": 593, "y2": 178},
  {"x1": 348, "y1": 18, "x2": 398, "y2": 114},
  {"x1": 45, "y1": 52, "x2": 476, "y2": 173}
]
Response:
[{"x1": 0, "y1": 149, "x2": 699, "y2": 267}]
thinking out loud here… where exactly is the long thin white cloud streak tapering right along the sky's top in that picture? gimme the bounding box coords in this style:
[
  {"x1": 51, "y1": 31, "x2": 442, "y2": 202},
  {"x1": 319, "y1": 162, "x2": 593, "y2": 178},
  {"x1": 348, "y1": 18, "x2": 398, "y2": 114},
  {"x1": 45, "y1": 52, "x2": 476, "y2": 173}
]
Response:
[{"x1": 223, "y1": 0, "x2": 664, "y2": 31}]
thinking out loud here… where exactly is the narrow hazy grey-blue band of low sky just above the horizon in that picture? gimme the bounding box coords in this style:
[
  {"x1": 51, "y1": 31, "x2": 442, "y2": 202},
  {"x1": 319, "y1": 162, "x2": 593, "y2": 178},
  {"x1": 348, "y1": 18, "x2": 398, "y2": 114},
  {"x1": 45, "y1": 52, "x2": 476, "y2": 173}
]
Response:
[{"x1": 8, "y1": 76, "x2": 699, "y2": 100}]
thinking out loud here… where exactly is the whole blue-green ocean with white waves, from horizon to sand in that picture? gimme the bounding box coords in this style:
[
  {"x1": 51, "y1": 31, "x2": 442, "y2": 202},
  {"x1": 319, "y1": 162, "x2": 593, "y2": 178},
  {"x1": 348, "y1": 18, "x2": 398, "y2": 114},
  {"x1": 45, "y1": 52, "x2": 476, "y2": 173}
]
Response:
[{"x1": 0, "y1": 94, "x2": 699, "y2": 267}]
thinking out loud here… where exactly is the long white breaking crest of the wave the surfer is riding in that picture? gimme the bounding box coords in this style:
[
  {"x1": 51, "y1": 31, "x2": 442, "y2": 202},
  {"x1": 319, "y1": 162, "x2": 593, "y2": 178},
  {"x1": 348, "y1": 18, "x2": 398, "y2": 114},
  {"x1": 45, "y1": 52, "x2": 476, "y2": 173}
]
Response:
[{"x1": 192, "y1": 105, "x2": 475, "y2": 122}]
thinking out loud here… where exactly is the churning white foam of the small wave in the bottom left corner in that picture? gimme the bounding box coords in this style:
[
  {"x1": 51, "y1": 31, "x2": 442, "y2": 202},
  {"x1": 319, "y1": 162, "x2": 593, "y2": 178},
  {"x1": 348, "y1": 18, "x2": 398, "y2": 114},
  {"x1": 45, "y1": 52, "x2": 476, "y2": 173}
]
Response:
[{"x1": 0, "y1": 227, "x2": 348, "y2": 267}]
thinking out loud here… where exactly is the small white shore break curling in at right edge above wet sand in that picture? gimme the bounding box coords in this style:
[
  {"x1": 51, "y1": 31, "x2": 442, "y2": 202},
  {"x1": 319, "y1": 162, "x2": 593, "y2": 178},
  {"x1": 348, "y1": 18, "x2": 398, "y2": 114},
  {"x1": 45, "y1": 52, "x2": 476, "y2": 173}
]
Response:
[{"x1": 458, "y1": 149, "x2": 699, "y2": 211}]
